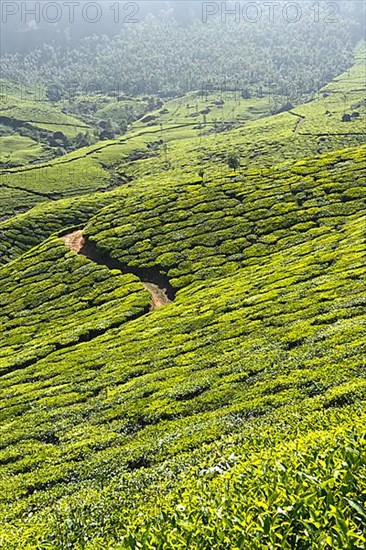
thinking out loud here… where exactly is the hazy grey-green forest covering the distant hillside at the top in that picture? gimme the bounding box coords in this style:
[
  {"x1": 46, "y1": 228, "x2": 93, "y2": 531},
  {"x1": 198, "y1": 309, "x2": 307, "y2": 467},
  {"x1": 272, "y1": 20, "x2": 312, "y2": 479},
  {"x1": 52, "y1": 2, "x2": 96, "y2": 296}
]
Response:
[{"x1": 1, "y1": 2, "x2": 362, "y2": 99}]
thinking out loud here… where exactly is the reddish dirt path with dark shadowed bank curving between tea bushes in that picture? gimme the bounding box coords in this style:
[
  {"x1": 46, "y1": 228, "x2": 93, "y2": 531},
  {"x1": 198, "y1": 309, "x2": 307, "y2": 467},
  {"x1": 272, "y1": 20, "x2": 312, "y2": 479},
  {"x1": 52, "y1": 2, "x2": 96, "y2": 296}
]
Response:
[{"x1": 61, "y1": 230, "x2": 175, "y2": 309}]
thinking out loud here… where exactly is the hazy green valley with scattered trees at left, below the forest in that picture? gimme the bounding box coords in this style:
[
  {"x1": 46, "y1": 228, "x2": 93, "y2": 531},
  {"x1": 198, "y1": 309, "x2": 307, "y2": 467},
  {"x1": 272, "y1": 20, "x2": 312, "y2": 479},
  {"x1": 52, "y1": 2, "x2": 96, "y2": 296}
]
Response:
[{"x1": 0, "y1": 80, "x2": 156, "y2": 169}]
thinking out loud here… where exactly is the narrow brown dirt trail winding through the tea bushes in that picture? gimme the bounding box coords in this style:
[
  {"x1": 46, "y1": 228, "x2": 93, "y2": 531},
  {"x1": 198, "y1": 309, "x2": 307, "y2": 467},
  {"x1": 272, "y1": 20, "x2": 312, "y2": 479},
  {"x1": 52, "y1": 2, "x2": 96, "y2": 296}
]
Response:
[{"x1": 61, "y1": 230, "x2": 172, "y2": 309}]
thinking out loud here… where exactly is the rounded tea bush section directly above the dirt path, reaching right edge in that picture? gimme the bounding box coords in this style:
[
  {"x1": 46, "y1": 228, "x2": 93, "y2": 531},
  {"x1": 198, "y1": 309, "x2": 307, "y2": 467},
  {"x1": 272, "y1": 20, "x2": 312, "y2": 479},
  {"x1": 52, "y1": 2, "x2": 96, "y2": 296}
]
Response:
[{"x1": 85, "y1": 149, "x2": 366, "y2": 294}]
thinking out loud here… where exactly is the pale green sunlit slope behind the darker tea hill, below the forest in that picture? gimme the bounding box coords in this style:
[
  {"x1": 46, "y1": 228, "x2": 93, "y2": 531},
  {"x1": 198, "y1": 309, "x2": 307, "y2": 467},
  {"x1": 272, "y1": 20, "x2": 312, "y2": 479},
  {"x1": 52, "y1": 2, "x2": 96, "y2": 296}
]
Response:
[{"x1": 0, "y1": 48, "x2": 366, "y2": 221}]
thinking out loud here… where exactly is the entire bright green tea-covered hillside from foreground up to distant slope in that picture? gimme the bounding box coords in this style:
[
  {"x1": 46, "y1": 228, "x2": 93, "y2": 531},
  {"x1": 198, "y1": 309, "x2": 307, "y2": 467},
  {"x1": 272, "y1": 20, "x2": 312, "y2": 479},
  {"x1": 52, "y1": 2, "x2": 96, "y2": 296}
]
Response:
[{"x1": 0, "y1": 45, "x2": 366, "y2": 550}]
